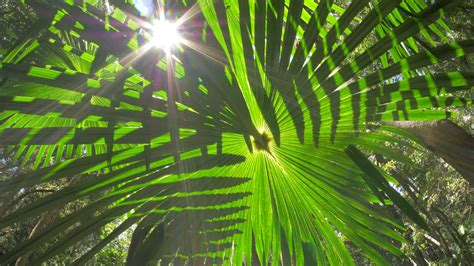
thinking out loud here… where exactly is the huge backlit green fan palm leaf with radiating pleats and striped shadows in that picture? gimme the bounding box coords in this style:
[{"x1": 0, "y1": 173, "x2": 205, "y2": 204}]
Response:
[{"x1": 0, "y1": 0, "x2": 474, "y2": 265}]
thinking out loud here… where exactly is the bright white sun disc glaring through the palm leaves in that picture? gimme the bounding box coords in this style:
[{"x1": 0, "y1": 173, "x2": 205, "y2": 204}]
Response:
[{"x1": 151, "y1": 20, "x2": 181, "y2": 52}]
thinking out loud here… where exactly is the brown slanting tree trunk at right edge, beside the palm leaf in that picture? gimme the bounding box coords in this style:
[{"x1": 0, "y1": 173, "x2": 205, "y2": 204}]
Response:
[{"x1": 383, "y1": 120, "x2": 474, "y2": 187}]
